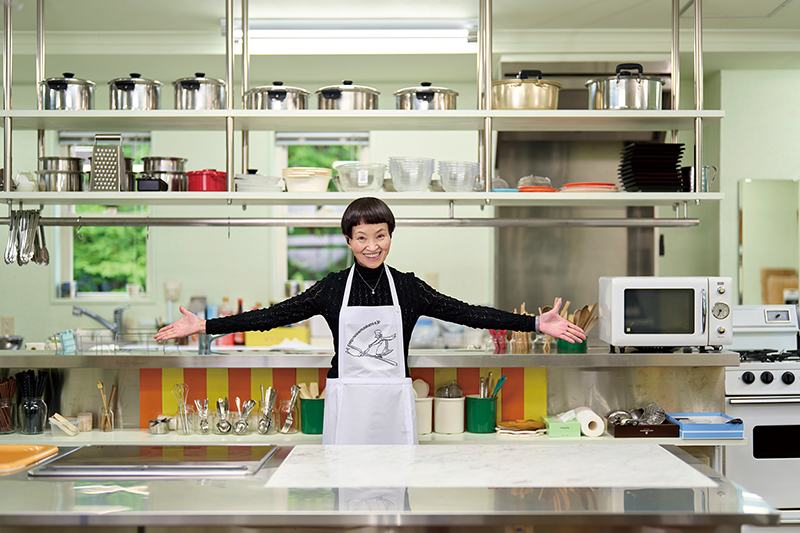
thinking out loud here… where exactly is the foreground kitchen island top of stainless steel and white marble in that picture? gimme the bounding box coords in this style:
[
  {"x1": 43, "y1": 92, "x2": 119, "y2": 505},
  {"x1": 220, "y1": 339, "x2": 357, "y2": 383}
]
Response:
[{"x1": 0, "y1": 444, "x2": 778, "y2": 532}]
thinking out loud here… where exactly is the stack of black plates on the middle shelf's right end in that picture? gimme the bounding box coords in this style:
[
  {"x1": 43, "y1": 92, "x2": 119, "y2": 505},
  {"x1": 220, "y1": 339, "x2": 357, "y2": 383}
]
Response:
[{"x1": 619, "y1": 143, "x2": 688, "y2": 192}]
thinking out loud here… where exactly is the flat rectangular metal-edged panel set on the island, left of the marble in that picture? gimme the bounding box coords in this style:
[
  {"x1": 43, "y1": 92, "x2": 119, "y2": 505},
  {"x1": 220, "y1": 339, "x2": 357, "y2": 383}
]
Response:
[{"x1": 28, "y1": 445, "x2": 277, "y2": 478}]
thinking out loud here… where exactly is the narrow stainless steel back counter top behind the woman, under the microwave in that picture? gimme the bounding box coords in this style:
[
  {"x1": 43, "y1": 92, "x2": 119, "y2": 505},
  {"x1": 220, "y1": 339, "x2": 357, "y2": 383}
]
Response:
[{"x1": 0, "y1": 347, "x2": 739, "y2": 368}]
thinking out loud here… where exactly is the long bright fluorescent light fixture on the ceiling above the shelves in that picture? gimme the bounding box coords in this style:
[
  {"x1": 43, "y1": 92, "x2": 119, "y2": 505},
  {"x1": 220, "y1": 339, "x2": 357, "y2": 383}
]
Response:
[{"x1": 222, "y1": 19, "x2": 477, "y2": 55}]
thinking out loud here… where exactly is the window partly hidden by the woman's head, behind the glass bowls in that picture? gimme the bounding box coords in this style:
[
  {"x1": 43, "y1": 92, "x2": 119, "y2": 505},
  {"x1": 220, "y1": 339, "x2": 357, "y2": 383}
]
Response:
[{"x1": 276, "y1": 133, "x2": 369, "y2": 281}]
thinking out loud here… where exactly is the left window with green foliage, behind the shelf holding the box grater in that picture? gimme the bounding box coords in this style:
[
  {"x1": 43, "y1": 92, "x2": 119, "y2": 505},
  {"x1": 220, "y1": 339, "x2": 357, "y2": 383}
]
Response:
[{"x1": 56, "y1": 132, "x2": 150, "y2": 299}]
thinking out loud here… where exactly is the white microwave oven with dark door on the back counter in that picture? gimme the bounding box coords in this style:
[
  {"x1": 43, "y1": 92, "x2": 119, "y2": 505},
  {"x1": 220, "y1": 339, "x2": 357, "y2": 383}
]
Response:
[{"x1": 598, "y1": 276, "x2": 733, "y2": 348}]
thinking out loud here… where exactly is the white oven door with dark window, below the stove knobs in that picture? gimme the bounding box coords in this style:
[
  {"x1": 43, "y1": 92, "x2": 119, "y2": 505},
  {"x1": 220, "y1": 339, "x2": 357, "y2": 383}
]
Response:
[{"x1": 725, "y1": 396, "x2": 800, "y2": 510}]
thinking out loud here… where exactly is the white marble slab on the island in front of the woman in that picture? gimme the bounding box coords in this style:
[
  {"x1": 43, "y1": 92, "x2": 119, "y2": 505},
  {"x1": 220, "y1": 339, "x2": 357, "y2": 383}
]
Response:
[{"x1": 267, "y1": 444, "x2": 716, "y2": 488}]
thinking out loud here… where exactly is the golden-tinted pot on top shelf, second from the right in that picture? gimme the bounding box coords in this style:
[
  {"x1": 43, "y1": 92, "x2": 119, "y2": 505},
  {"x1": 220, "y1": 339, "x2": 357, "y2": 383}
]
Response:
[{"x1": 492, "y1": 70, "x2": 561, "y2": 109}]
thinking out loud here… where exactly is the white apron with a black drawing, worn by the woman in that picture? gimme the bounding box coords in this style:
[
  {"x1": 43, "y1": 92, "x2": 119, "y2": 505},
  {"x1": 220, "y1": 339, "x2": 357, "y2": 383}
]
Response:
[{"x1": 322, "y1": 264, "x2": 417, "y2": 444}]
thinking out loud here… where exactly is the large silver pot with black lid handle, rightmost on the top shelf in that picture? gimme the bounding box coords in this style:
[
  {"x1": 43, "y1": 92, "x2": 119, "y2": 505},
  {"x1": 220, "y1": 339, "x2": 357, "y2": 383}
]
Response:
[{"x1": 586, "y1": 63, "x2": 664, "y2": 110}]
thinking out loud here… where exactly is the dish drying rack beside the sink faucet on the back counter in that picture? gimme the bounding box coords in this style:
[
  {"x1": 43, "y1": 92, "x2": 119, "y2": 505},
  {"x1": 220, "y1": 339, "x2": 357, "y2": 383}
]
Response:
[{"x1": 51, "y1": 328, "x2": 180, "y2": 355}]
